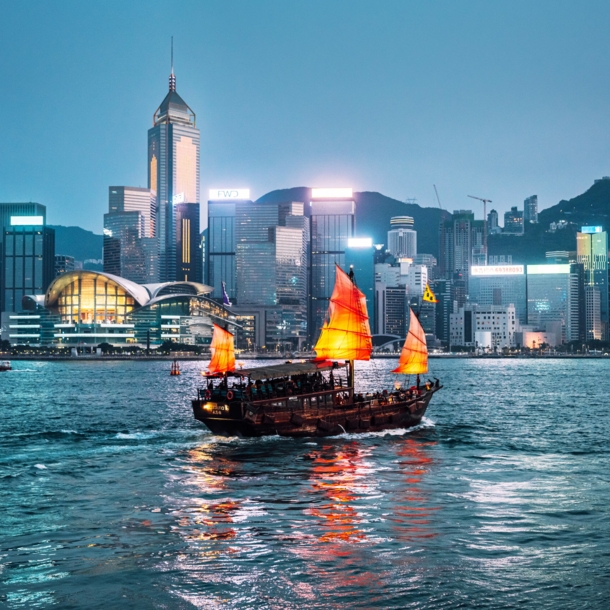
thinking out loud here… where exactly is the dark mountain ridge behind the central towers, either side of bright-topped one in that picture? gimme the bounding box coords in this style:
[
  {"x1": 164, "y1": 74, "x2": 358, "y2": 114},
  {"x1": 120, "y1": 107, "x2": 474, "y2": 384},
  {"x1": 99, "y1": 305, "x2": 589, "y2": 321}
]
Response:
[{"x1": 256, "y1": 186, "x2": 450, "y2": 257}]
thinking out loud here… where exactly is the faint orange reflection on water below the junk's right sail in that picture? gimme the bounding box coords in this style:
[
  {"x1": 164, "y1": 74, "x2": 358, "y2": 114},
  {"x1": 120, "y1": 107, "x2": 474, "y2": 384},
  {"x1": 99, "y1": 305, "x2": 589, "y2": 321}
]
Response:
[{"x1": 391, "y1": 438, "x2": 440, "y2": 540}]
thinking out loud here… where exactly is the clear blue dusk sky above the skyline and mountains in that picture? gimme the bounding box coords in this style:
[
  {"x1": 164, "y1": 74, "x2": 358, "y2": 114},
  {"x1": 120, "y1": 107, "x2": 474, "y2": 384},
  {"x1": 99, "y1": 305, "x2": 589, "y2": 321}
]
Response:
[{"x1": 0, "y1": 0, "x2": 610, "y2": 233}]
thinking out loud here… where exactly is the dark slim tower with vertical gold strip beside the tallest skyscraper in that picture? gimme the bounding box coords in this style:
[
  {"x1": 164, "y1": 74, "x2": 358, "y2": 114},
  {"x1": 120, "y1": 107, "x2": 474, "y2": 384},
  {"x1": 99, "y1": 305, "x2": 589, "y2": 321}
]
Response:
[{"x1": 174, "y1": 203, "x2": 203, "y2": 282}]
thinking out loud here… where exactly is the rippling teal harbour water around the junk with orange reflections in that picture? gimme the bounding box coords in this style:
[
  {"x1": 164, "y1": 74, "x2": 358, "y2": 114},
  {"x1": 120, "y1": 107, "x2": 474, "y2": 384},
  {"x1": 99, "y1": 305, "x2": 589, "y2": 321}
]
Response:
[{"x1": 0, "y1": 360, "x2": 610, "y2": 610}]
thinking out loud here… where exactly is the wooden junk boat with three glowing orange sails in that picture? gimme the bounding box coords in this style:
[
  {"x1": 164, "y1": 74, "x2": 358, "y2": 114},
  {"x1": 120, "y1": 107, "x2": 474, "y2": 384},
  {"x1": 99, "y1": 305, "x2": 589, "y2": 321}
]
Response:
[{"x1": 192, "y1": 266, "x2": 441, "y2": 437}]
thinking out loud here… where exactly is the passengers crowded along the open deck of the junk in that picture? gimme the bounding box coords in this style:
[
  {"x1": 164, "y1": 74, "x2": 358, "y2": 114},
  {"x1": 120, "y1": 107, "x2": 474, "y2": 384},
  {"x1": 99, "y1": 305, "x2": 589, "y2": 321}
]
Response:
[{"x1": 202, "y1": 371, "x2": 439, "y2": 403}]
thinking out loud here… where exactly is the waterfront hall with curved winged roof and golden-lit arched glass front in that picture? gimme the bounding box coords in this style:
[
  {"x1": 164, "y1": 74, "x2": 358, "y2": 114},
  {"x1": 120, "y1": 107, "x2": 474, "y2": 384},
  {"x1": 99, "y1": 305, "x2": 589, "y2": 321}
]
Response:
[{"x1": 3, "y1": 270, "x2": 234, "y2": 347}]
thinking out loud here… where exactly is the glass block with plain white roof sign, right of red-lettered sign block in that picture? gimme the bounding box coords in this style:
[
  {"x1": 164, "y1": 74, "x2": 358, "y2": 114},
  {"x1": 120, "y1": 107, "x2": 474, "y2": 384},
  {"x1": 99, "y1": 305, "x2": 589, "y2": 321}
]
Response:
[{"x1": 527, "y1": 264, "x2": 580, "y2": 342}]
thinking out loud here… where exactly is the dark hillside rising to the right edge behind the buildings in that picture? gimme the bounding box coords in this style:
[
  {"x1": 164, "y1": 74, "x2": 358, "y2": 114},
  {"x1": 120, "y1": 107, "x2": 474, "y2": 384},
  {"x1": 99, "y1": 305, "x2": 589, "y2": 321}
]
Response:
[{"x1": 488, "y1": 179, "x2": 610, "y2": 264}]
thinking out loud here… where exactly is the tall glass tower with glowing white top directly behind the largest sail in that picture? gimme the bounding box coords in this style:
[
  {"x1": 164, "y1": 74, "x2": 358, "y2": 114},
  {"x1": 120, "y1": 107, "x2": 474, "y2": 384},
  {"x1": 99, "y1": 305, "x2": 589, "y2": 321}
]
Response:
[{"x1": 309, "y1": 188, "x2": 356, "y2": 343}]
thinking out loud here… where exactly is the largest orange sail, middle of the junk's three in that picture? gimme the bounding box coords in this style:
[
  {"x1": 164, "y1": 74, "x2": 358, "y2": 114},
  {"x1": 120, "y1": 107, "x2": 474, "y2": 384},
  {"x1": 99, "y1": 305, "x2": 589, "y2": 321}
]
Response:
[{"x1": 314, "y1": 265, "x2": 373, "y2": 360}]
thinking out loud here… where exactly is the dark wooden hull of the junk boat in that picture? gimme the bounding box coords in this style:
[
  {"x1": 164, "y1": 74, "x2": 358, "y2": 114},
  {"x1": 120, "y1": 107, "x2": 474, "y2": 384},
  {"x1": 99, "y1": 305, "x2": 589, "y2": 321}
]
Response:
[{"x1": 192, "y1": 387, "x2": 440, "y2": 437}]
